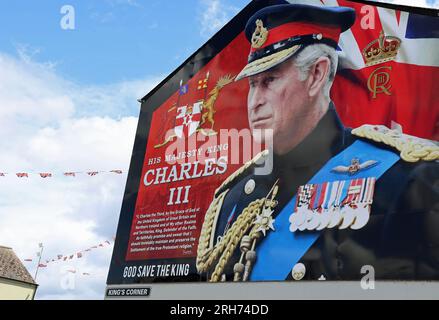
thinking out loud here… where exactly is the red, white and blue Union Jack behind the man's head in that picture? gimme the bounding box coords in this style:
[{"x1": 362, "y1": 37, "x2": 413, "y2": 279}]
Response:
[{"x1": 294, "y1": 0, "x2": 439, "y2": 140}]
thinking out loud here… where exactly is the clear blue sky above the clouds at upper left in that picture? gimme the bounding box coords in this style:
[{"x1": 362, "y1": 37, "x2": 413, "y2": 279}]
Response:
[{"x1": 0, "y1": 0, "x2": 249, "y2": 84}]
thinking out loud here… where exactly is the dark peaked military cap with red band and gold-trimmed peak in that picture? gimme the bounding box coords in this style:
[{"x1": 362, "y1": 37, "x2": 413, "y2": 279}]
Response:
[{"x1": 236, "y1": 4, "x2": 355, "y2": 80}]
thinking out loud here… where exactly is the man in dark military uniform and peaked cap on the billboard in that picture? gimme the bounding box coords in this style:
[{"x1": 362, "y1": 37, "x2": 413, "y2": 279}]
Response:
[{"x1": 197, "y1": 4, "x2": 439, "y2": 282}]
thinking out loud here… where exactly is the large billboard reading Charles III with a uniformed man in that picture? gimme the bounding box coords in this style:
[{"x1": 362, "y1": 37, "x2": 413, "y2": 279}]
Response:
[{"x1": 107, "y1": 0, "x2": 439, "y2": 285}]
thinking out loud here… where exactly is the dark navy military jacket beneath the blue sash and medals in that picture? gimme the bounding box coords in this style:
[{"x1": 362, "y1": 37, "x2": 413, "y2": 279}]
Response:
[{"x1": 197, "y1": 103, "x2": 439, "y2": 281}]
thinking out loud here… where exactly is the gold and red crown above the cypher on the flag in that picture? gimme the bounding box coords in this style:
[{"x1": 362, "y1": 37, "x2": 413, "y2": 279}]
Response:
[{"x1": 363, "y1": 31, "x2": 401, "y2": 67}]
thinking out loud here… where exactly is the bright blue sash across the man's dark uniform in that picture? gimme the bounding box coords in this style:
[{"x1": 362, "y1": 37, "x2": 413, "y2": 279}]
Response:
[{"x1": 250, "y1": 140, "x2": 399, "y2": 281}]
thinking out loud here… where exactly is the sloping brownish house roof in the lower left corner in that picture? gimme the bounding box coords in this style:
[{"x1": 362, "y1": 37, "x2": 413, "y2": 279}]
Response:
[{"x1": 0, "y1": 246, "x2": 36, "y2": 284}]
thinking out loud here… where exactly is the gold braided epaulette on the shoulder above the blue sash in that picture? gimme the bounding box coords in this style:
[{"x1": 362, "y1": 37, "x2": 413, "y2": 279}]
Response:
[{"x1": 352, "y1": 124, "x2": 439, "y2": 162}]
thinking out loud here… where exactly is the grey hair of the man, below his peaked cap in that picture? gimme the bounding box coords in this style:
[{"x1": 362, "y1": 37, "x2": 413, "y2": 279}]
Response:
[{"x1": 293, "y1": 43, "x2": 338, "y2": 99}]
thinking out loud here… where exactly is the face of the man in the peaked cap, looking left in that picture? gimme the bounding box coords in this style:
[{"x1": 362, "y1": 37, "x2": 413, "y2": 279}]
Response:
[{"x1": 247, "y1": 59, "x2": 310, "y2": 153}]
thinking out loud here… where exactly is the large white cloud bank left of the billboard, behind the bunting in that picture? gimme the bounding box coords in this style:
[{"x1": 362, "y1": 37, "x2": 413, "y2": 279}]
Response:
[{"x1": 0, "y1": 48, "x2": 161, "y2": 299}]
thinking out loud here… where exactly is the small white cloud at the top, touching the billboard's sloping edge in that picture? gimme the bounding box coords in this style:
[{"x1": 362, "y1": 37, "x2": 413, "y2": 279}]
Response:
[{"x1": 200, "y1": 0, "x2": 239, "y2": 38}]
